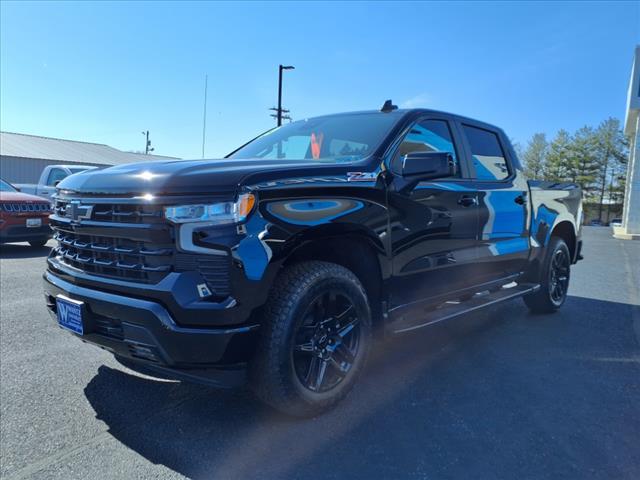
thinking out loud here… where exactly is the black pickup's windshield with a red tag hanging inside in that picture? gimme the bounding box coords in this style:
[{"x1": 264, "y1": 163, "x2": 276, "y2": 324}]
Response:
[{"x1": 230, "y1": 112, "x2": 401, "y2": 163}]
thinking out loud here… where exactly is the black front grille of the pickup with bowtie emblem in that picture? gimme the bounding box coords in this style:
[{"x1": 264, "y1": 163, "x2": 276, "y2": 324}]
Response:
[{"x1": 50, "y1": 199, "x2": 231, "y2": 297}]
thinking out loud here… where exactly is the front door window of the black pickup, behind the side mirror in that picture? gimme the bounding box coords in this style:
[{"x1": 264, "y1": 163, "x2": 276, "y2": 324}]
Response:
[{"x1": 394, "y1": 120, "x2": 460, "y2": 176}]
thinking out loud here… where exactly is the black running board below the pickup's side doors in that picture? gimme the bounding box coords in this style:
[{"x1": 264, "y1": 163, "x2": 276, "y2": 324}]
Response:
[{"x1": 388, "y1": 283, "x2": 540, "y2": 334}]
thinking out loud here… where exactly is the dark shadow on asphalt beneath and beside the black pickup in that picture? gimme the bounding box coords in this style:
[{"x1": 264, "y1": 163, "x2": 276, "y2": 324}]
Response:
[{"x1": 85, "y1": 297, "x2": 640, "y2": 479}]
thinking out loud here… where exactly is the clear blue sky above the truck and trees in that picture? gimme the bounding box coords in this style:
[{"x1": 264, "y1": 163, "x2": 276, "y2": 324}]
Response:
[{"x1": 0, "y1": 1, "x2": 640, "y2": 158}]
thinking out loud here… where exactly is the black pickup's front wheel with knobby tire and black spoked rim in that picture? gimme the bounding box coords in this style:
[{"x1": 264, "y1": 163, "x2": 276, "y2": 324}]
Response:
[{"x1": 250, "y1": 261, "x2": 371, "y2": 417}]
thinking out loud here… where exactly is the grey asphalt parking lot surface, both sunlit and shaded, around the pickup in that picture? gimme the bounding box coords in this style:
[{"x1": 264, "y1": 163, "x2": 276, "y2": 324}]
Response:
[{"x1": 0, "y1": 227, "x2": 640, "y2": 479}]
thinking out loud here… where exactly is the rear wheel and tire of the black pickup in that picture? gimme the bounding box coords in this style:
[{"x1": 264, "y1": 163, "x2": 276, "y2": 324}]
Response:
[{"x1": 523, "y1": 237, "x2": 571, "y2": 313}]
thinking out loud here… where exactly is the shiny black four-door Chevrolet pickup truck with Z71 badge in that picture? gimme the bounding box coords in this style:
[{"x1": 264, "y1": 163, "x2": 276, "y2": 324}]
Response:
[{"x1": 44, "y1": 102, "x2": 582, "y2": 415}]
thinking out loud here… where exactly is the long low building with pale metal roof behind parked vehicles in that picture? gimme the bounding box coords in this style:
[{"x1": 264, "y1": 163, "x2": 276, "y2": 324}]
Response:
[{"x1": 0, "y1": 132, "x2": 177, "y2": 183}]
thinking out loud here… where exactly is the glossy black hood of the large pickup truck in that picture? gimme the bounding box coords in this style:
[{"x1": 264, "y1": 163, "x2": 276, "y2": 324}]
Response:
[{"x1": 58, "y1": 159, "x2": 356, "y2": 196}]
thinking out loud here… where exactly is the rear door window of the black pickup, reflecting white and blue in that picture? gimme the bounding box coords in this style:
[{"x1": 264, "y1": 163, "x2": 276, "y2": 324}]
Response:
[{"x1": 462, "y1": 125, "x2": 509, "y2": 180}]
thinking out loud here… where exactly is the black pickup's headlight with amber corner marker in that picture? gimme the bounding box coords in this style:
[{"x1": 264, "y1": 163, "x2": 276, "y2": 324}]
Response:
[{"x1": 164, "y1": 193, "x2": 256, "y2": 225}]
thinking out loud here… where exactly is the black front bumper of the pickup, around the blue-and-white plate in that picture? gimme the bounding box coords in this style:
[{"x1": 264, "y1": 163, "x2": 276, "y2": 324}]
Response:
[{"x1": 43, "y1": 271, "x2": 258, "y2": 386}]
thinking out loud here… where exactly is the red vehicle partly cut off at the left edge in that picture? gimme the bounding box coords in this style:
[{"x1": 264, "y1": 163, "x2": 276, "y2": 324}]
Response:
[{"x1": 0, "y1": 179, "x2": 52, "y2": 247}]
